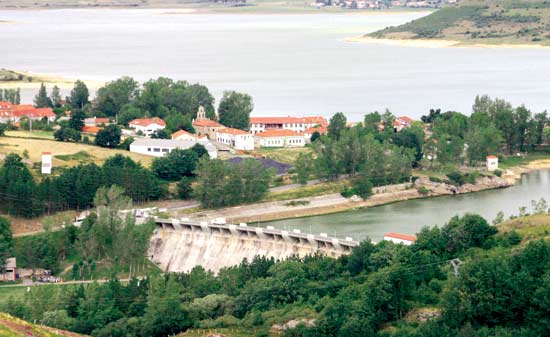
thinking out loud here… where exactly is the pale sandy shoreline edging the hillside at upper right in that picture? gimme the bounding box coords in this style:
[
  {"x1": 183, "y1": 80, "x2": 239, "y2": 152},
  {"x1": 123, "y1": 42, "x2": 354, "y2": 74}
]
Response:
[{"x1": 350, "y1": 36, "x2": 550, "y2": 49}]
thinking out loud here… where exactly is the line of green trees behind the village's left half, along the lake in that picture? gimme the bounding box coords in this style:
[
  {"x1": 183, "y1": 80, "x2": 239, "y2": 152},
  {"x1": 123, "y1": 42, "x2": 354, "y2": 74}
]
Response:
[{"x1": 29, "y1": 76, "x2": 254, "y2": 148}]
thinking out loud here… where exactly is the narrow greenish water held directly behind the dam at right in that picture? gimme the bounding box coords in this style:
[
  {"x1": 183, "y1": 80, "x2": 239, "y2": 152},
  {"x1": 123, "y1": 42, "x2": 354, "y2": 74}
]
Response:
[{"x1": 260, "y1": 170, "x2": 550, "y2": 241}]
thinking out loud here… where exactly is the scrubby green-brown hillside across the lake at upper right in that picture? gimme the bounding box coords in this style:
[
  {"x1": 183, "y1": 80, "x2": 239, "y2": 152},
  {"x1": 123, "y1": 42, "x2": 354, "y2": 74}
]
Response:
[{"x1": 368, "y1": 0, "x2": 550, "y2": 45}]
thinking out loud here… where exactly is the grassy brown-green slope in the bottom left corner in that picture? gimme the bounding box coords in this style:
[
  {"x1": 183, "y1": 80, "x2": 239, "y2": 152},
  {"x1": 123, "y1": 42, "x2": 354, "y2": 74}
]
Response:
[{"x1": 0, "y1": 313, "x2": 84, "y2": 337}]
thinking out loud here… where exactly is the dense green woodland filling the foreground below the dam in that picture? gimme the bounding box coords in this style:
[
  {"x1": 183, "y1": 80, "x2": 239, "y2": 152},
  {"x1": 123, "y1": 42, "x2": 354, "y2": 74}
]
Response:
[{"x1": 0, "y1": 214, "x2": 550, "y2": 337}]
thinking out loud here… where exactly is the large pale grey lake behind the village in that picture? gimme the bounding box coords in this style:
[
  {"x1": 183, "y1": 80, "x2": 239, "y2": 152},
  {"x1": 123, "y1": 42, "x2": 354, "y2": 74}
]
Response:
[{"x1": 0, "y1": 9, "x2": 550, "y2": 120}]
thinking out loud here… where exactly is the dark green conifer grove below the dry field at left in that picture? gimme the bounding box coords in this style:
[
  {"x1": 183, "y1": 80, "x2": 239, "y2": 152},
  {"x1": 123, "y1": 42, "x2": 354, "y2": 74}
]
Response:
[{"x1": 0, "y1": 154, "x2": 164, "y2": 217}]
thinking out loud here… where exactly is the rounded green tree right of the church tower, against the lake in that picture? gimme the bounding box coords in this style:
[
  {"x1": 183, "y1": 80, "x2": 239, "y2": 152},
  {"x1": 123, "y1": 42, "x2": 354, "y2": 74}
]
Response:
[{"x1": 218, "y1": 91, "x2": 254, "y2": 130}]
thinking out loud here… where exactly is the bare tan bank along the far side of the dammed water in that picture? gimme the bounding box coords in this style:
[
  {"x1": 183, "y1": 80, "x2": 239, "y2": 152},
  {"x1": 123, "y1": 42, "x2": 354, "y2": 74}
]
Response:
[{"x1": 183, "y1": 159, "x2": 550, "y2": 224}]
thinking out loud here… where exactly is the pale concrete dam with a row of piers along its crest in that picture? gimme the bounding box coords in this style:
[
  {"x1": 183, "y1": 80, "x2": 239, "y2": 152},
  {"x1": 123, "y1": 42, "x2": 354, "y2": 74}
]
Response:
[{"x1": 148, "y1": 219, "x2": 358, "y2": 273}]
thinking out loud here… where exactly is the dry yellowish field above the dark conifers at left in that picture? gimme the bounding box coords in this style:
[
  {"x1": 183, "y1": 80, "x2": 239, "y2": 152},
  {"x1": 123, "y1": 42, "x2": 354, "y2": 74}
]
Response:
[{"x1": 0, "y1": 135, "x2": 152, "y2": 168}]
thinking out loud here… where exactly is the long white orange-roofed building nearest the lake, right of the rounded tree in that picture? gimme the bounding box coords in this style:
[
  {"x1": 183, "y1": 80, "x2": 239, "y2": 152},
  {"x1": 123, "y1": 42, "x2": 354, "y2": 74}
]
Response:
[{"x1": 250, "y1": 116, "x2": 328, "y2": 134}]
